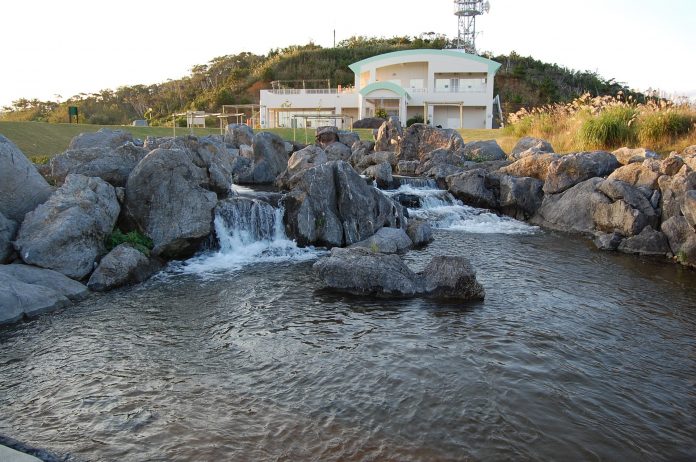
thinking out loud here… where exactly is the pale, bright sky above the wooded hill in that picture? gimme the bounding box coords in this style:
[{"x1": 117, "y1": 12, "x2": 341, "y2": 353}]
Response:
[{"x1": 0, "y1": 0, "x2": 696, "y2": 107}]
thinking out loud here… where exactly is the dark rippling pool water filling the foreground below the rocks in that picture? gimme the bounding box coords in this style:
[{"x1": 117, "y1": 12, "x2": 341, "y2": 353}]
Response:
[{"x1": 0, "y1": 218, "x2": 696, "y2": 461}]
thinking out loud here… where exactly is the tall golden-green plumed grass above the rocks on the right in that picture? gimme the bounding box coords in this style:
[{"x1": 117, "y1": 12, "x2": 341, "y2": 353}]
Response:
[{"x1": 506, "y1": 94, "x2": 696, "y2": 152}]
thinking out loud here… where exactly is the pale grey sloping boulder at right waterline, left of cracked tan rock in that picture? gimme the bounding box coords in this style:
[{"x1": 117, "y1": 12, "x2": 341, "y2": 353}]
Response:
[{"x1": 530, "y1": 178, "x2": 613, "y2": 233}]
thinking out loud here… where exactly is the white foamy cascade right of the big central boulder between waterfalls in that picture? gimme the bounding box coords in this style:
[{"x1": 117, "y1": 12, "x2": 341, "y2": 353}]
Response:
[{"x1": 386, "y1": 185, "x2": 539, "y2": 234}]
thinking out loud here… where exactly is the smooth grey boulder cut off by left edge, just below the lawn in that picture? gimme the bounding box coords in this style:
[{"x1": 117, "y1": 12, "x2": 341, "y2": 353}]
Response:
[{"x1": 0, "y1": 135, "x2": 53, "y2": 223}]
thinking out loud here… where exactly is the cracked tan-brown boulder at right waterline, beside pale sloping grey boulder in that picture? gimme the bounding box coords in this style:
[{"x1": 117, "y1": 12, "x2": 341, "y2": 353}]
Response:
[{"x1": 592, "y1": 180, "x2": 659, "y2": 236}]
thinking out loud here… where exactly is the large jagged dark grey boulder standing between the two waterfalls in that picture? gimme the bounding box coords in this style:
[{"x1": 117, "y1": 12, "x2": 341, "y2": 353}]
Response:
[{"x1": 284, "y1": 161, "x2": 405, "y2": 247}]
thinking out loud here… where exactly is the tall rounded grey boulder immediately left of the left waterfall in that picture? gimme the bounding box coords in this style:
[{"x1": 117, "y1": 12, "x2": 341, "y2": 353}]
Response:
[{"x1": 125, "y1": 149, "x2": 217, "y2": 258}]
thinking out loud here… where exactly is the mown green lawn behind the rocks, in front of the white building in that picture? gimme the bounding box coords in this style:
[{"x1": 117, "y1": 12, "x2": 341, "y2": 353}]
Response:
[{"x1": 0, "y1": 121, "x2": 516, "y2": 160}]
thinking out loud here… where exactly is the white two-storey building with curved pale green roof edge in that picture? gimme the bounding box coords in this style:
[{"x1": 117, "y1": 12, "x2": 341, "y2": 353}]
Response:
[{"x1": 260, "y1": 49, "x2": 500, "y2": 128}]
